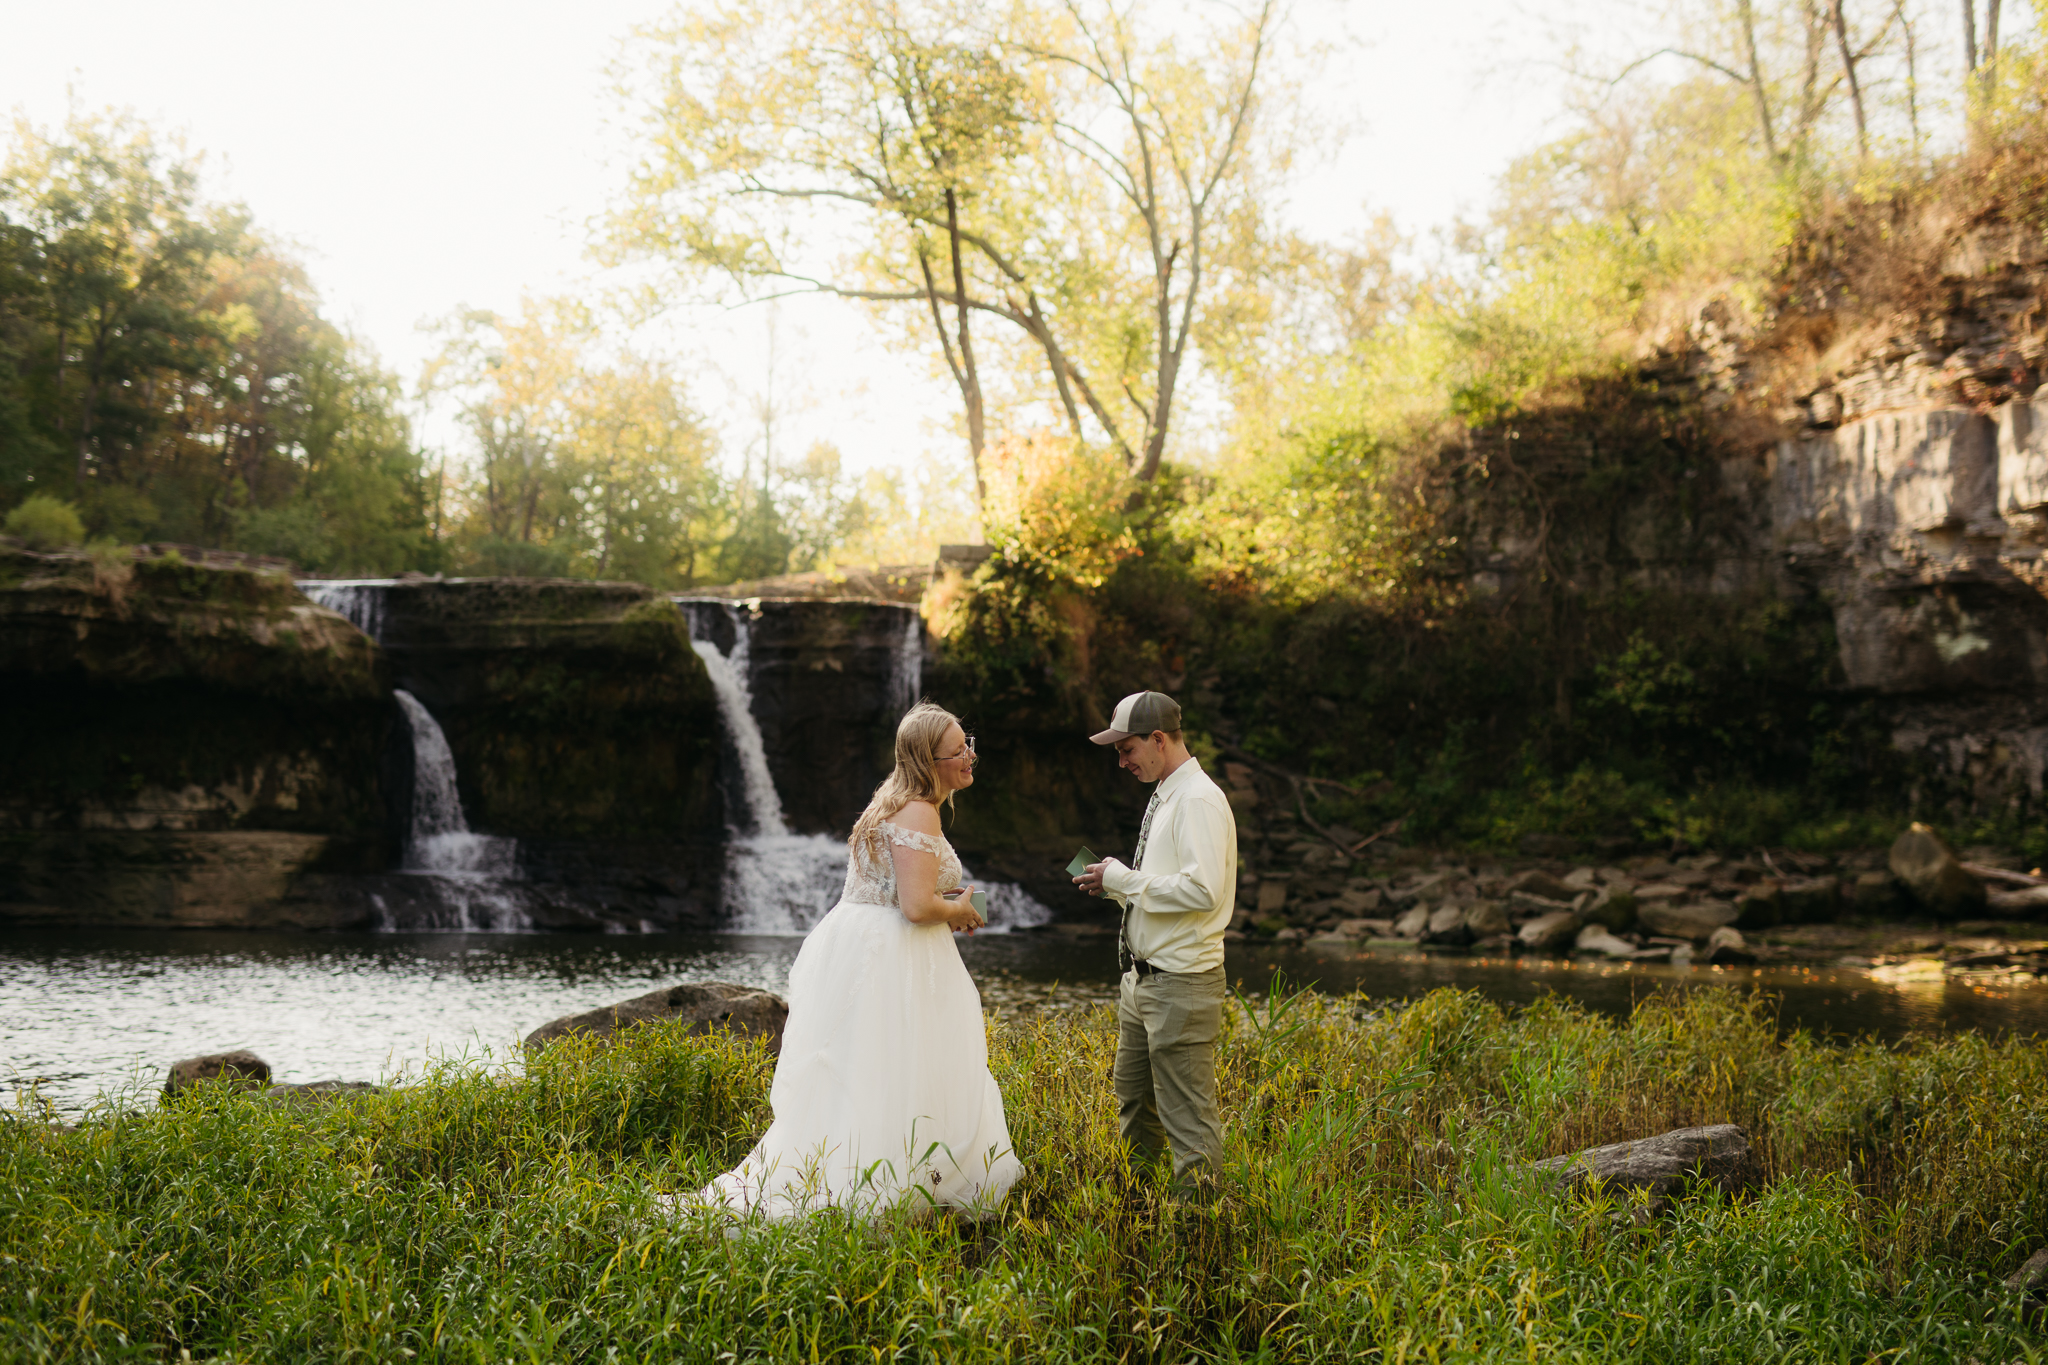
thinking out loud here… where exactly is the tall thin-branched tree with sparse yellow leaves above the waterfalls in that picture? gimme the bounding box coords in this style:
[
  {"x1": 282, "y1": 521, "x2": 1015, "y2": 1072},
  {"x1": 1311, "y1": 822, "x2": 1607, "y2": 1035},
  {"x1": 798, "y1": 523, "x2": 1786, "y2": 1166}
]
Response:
[{"x1": 608, "y1": 0, "x2": 1290, "y2": 489}]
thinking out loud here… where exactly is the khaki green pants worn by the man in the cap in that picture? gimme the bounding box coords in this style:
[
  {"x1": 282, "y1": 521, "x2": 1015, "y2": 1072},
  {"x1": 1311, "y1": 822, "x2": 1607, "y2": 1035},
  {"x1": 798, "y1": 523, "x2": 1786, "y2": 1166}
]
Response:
[{"x1": 1116, "y1": 966, "x2": 1225, "y2": 1181}]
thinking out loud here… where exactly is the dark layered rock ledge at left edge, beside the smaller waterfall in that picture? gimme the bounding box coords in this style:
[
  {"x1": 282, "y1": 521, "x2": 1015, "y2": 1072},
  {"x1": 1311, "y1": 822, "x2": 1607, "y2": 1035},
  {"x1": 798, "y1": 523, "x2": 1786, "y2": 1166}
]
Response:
[{"x1": 0, "y1": 546, "x2": 395, "y2": 927}]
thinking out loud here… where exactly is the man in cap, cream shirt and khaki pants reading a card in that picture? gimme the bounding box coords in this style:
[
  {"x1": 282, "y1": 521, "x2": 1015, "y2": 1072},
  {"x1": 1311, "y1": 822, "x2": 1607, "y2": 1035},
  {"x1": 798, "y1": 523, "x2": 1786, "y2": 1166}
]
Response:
[{"x1": 1073, "y1": 692, "x2": 1237, "y2": 1185}]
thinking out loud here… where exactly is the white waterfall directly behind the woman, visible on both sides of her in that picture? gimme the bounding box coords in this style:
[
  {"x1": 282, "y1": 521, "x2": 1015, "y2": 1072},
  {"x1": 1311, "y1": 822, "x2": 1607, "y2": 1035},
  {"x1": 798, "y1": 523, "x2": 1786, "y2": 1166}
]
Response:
[{"x1": 690, "y1": 604, "x2": 1053, "y2": 935}]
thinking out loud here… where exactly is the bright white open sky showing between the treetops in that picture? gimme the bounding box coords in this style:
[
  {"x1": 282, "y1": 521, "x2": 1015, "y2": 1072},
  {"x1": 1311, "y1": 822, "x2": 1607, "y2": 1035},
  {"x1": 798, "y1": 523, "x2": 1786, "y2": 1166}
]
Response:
[{"x1": 0, "y1": 0, "x2": 1559, "y2": 489}]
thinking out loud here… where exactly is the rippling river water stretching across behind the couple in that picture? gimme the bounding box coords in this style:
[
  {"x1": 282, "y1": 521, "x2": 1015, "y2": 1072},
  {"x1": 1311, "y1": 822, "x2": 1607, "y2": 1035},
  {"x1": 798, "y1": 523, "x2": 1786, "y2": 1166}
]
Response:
[{"x1": 0, "y1": 929, "x2": 2048, "y2": 1113}]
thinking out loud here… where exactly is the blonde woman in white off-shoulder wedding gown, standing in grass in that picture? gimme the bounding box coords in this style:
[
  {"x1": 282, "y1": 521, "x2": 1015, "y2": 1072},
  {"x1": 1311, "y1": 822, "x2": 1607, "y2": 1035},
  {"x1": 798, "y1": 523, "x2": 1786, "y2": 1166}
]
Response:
[{"x1": 694, "y1": 702, "x2": 1024, "y2": 1220}]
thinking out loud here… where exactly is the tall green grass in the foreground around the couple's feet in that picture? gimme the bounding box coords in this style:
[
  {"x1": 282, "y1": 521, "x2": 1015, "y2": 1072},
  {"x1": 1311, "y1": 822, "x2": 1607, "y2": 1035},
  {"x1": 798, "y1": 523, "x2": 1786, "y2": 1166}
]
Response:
[{"x1": 0, "y1": 990, "x2": 2048, "y2": 1365}]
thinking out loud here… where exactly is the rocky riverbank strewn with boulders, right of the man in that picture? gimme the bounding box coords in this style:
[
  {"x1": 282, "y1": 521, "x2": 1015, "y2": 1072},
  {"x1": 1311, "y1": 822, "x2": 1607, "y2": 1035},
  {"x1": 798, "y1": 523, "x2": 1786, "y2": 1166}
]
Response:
[{"x1": 1223, "y1": 794, "x2": 2048, "y2": 980}]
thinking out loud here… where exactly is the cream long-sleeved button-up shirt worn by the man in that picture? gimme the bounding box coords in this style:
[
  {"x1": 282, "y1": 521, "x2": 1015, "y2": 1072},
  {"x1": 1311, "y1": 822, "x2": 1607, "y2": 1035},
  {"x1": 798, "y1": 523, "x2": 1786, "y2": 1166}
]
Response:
[{"x1": 1102, "y1": 755, "x2": 1237, "y2": 972}]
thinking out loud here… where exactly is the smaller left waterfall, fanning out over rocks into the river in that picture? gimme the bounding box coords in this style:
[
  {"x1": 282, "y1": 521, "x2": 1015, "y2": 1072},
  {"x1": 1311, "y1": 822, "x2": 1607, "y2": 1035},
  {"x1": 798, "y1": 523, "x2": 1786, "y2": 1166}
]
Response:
[{"x1": 379, "y1": 690, "x2": 532, "y2": 929}]
